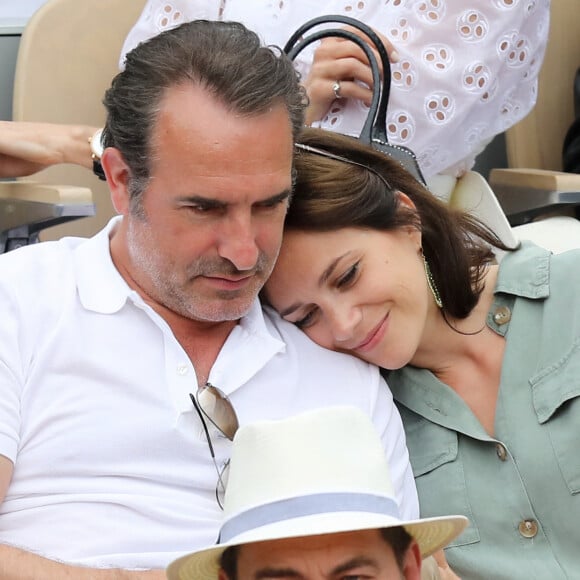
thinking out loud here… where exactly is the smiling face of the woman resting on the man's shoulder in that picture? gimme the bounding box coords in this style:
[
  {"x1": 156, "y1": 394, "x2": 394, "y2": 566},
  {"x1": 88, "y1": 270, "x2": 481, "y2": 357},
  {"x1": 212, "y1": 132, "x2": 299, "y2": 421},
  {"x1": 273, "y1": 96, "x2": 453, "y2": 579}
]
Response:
[{"x1": 265, "y1": 227, "x2": 432, "y2": 369}]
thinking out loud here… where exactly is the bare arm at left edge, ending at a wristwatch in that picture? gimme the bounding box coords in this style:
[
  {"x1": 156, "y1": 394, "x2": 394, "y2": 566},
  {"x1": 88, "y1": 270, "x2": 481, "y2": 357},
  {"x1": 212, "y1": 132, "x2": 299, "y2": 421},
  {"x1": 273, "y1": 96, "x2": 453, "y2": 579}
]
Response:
[{"x1": 0, "y1": 121, "x2": 96, "y2": 177}]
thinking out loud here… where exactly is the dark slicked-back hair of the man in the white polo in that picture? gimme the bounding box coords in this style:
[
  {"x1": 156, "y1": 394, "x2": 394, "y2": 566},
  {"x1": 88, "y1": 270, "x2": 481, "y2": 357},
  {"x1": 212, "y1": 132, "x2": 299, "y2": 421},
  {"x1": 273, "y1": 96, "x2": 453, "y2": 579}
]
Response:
[{"x1": 103, "y1": 20, "x2": 307, "y2": 208}]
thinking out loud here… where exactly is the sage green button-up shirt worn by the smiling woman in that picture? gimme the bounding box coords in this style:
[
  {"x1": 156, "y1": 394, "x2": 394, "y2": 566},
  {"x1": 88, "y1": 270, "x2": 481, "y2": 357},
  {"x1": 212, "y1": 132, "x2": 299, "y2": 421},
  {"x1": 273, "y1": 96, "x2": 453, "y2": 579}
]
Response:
[{"x1": 388, "y1": 243, "x2": 580, "y2": 580}]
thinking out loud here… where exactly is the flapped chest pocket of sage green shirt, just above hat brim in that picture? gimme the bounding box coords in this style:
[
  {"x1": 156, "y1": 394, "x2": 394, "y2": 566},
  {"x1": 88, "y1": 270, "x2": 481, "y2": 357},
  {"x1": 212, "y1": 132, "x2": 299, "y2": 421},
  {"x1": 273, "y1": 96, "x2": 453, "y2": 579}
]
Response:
[{"x1": 400, "y1": 406, "x2": 480, "y2": 547}]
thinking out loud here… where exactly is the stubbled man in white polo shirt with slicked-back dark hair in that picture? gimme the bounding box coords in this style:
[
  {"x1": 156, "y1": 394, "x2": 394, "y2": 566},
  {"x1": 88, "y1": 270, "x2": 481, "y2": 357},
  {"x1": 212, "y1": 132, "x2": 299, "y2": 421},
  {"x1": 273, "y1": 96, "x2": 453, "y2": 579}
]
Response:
[{"x1": 0, "y1": 21, "x2": 418, "y2": 580}]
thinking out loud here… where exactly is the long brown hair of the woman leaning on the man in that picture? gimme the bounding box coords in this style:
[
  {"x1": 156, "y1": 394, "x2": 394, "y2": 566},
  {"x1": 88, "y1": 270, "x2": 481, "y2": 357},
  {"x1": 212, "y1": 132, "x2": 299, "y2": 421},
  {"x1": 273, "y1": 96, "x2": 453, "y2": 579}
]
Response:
[{"x1": 285, "y1": 129, "x2": 513, "y2": 318}]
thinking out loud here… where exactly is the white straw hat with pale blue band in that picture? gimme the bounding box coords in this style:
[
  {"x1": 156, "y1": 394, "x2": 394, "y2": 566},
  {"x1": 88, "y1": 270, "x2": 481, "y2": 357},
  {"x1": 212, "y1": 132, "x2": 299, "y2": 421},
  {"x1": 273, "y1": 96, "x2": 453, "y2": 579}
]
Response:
[{"x1": 167, "y1": 407, "x2": 468, "y2": 580}]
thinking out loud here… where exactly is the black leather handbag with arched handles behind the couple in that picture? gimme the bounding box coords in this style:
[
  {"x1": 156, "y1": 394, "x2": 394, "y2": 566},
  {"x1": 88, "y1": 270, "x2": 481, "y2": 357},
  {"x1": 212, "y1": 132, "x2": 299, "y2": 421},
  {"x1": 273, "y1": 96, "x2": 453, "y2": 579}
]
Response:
[{"x1": 284, "y1": 14, "x2": 425, "y2": 184}]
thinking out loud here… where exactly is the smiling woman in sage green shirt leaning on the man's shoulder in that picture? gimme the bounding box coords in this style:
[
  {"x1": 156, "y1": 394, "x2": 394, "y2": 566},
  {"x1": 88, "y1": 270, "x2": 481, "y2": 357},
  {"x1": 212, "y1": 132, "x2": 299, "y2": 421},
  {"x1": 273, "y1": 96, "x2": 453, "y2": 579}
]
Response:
[{"x1": 264, "y1": 129, "x2": 580, "y2": 580}]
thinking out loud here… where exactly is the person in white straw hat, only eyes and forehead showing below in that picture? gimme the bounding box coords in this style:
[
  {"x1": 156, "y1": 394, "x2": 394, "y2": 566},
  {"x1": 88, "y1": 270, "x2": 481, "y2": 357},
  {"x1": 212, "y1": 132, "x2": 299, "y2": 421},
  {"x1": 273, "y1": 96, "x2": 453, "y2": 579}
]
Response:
[{"x1": 167, "y1": 406, "x2": 468, "y2": 580}]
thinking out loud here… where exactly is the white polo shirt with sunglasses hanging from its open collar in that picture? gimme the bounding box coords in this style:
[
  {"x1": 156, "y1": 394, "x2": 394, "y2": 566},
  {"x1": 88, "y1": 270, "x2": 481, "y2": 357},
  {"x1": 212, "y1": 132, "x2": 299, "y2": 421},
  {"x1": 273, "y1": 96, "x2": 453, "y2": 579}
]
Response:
[{"x1": 0, "y1": 220, "x2": 418, "y2": 568}]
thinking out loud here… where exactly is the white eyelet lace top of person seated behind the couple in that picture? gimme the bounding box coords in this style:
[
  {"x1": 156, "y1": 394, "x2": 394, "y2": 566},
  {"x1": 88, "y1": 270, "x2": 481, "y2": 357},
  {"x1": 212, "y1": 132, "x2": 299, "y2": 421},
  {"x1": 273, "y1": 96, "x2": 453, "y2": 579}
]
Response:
[{"x1": 123, "y1": 0, "x2": 549, "y2": 177}]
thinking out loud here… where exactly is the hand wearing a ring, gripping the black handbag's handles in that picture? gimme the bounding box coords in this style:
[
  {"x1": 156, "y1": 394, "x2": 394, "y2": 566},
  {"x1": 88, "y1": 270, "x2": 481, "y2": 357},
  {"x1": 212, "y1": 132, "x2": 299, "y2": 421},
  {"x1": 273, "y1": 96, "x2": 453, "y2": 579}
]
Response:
[{"x1": 304, "y1": 26, "x2": 399, "y2": 124}]
